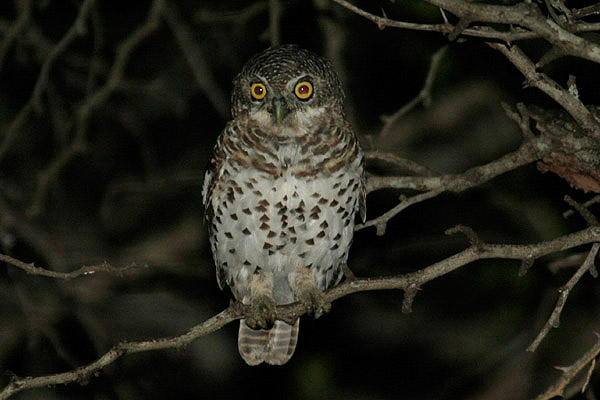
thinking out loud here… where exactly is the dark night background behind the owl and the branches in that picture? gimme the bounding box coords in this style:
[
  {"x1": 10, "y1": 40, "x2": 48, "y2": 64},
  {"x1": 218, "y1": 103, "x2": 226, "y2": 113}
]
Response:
[{"x1": 0, "y1": 0, "x2": 600, "y2": 399}]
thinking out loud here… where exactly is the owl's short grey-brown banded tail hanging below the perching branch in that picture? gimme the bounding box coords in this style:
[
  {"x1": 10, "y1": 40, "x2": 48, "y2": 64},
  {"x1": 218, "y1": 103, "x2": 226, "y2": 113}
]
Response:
[{"x1": 238, "y1": 318, "x2": 300, "y2": 365}]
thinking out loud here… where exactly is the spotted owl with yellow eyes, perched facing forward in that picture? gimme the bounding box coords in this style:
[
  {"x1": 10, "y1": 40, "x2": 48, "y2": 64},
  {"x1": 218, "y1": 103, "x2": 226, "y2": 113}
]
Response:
[{"x1": 202, "y1": 45, "x2": 365, "y2": 365}]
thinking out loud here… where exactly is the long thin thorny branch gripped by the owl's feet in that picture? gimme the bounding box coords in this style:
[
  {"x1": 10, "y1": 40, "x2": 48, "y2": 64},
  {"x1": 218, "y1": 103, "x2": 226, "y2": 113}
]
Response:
[{"x1": 0, "y1": 227, "x2": 600, "y2": 400}]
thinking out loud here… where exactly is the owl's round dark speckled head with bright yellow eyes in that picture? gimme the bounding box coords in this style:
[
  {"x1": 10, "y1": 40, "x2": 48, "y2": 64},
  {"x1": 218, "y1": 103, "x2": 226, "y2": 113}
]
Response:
[{"x1": 231, "y1": 45, "x2": 344, "y2": 126}]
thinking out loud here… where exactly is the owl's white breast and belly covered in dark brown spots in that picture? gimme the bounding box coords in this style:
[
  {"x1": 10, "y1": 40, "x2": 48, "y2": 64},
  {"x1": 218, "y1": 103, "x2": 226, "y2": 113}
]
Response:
[{"x1": 212, "y1": 159, "x2": 360, "y2": 290}]
